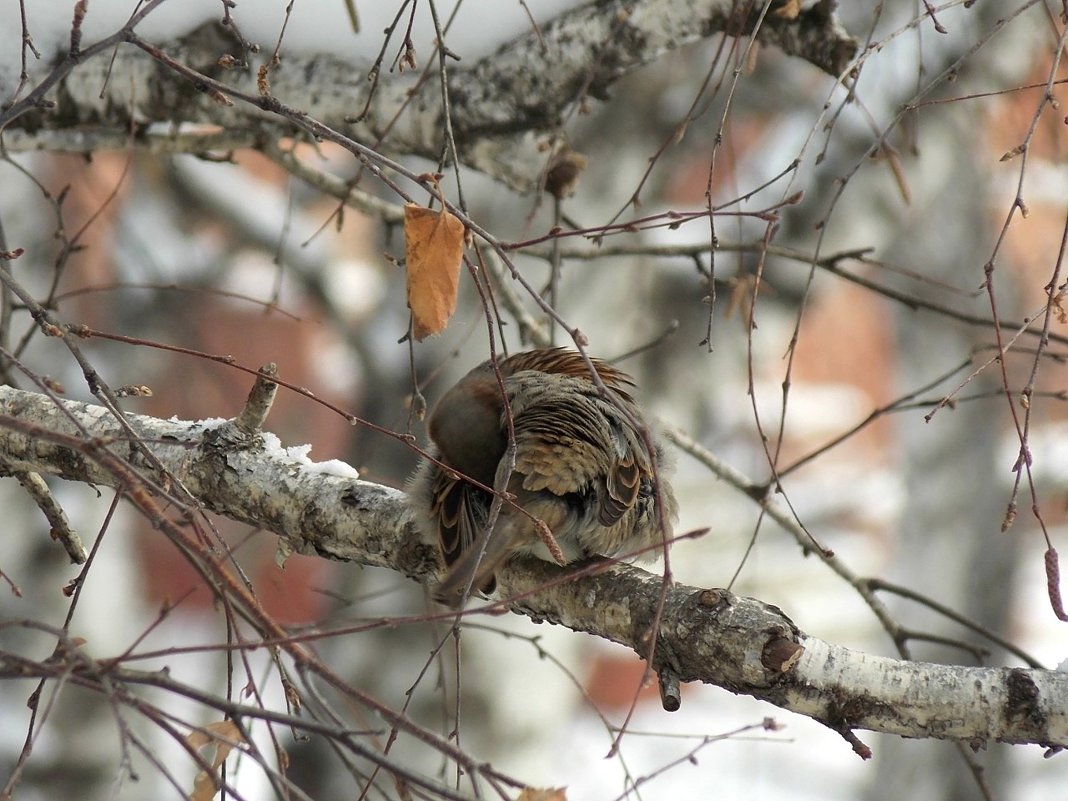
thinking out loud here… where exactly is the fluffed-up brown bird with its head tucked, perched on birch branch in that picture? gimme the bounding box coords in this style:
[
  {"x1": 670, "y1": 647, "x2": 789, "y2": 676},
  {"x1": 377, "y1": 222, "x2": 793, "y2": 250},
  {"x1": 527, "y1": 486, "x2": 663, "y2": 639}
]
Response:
[{"x1": 408, "y1": 347, "x2": 678, "y2": 608}]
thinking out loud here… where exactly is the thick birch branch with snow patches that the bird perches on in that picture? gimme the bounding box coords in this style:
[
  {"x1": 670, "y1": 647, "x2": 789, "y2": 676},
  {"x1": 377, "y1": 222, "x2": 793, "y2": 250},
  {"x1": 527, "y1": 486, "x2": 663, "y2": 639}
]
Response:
[{"x1": 0, "y1": 387, "x2": 1068, "y2": 755}]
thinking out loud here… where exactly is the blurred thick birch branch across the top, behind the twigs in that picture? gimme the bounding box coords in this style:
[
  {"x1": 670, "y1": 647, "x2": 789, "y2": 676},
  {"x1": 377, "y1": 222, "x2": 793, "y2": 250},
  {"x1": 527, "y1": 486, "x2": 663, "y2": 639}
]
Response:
[{"x1": 0, "y1": 0, "x2": 857, "y2": 189}]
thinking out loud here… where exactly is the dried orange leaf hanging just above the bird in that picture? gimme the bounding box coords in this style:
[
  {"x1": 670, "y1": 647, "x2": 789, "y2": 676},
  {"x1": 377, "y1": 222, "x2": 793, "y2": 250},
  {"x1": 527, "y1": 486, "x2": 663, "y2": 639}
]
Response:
[{"x1": 404, "y1": 203, "x2": 464, "y2": 341}]
